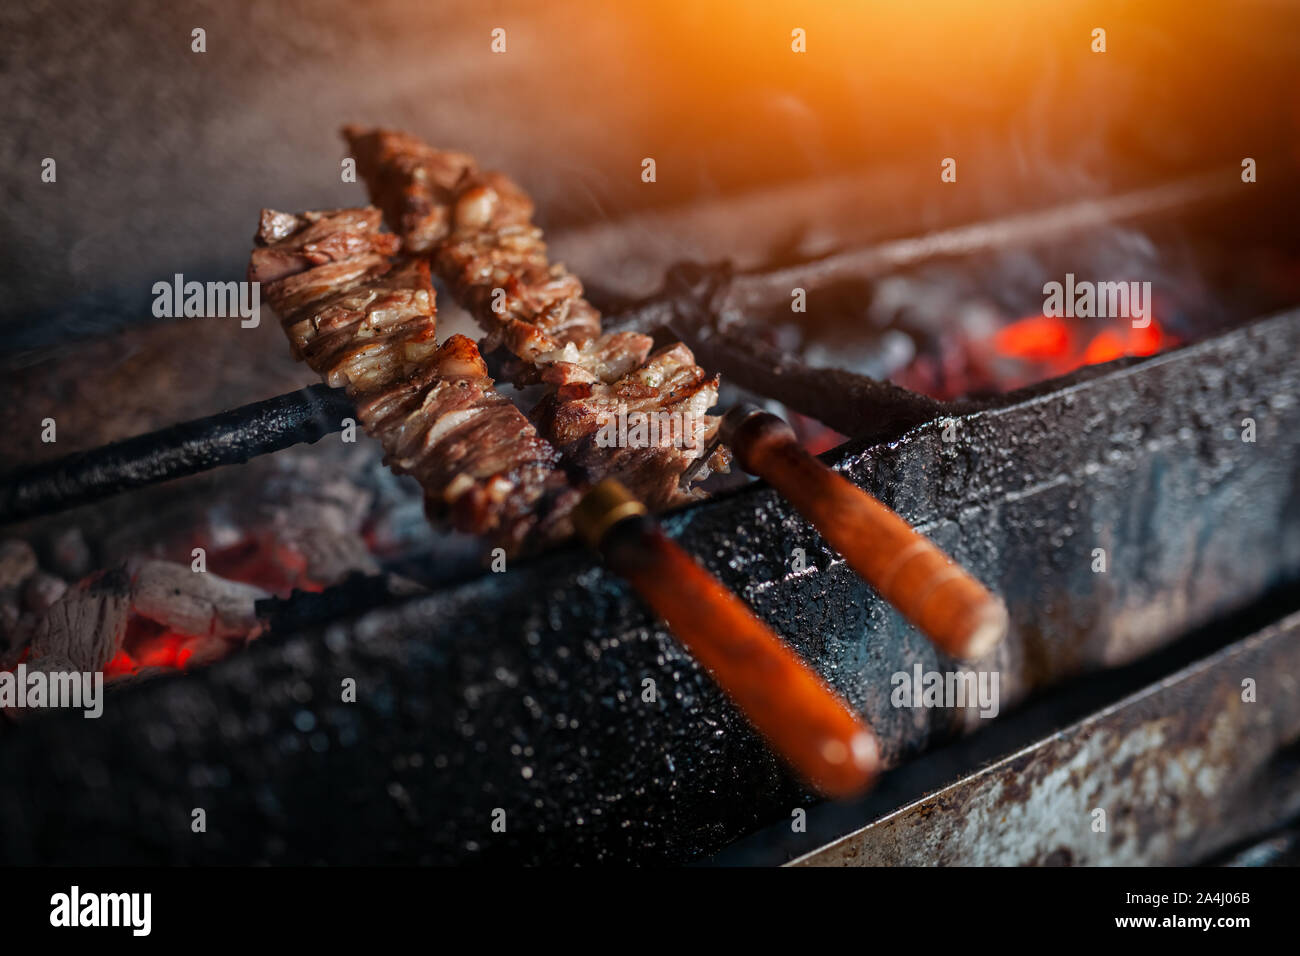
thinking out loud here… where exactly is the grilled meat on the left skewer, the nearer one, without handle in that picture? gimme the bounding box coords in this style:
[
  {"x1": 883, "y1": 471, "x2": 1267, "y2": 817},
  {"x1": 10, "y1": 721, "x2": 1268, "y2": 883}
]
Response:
[{"x1": 248, "y1": 208, "x2": 577, "y2": 553}]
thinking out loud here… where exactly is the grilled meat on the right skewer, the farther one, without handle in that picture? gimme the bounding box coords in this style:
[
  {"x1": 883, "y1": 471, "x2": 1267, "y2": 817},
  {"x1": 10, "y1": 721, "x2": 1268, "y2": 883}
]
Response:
[{"x1": 343, "y1": 126, "x2": 728, "y2": 510}]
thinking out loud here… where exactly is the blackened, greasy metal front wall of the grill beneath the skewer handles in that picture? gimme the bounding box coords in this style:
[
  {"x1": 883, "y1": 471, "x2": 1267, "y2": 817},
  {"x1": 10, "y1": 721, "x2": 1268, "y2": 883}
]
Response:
[{"x1": 0, "y1": 312, "x2": 1300, "y2": 862}]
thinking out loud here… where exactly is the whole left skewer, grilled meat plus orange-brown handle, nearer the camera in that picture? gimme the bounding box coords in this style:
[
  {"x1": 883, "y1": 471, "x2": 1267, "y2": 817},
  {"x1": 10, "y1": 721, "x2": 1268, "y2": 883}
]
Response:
[{"x1": 248, "y1": 209, "x2": 879, "y2": 796}]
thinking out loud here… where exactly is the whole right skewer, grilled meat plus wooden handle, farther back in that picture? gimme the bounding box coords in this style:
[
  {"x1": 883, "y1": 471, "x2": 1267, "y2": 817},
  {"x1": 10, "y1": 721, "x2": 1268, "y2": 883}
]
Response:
[{"x1": 345, "y1": 127, "x2": 1006, "y2": 657}]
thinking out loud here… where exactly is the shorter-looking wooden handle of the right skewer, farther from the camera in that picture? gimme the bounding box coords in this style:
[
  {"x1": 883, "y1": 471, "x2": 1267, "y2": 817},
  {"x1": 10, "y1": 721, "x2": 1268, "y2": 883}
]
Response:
[{"x1": 723, "y1": 407, "x2": 1008, "y2": 659}]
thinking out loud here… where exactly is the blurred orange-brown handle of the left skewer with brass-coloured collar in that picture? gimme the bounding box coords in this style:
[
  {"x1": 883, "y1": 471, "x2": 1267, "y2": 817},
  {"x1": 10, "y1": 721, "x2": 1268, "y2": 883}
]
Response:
[{"x1": 573, "y1": 481, "x2": 880, "y2": 797}]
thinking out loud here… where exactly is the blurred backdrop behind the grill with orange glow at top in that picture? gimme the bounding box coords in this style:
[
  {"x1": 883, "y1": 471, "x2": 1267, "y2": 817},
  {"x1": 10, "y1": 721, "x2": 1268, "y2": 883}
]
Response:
[{"x1": 0, "y1": 0, "x2": 1300, "y2": 358}]
